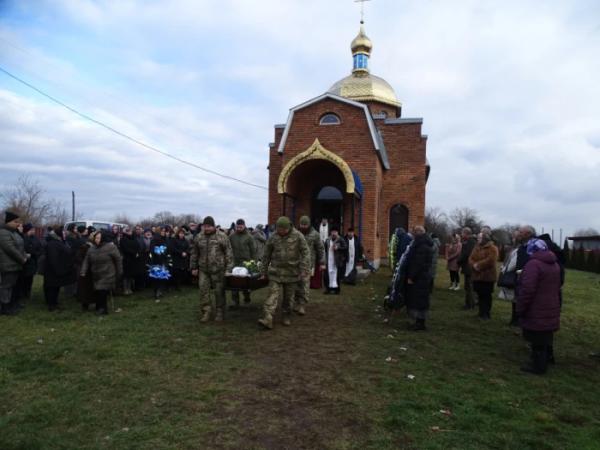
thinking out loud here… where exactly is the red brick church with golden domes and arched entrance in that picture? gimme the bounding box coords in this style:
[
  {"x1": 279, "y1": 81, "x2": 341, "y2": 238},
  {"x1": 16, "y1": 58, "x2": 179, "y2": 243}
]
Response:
[{"x1": 269, "y1": 22, "x2": 429, "y2": 266}]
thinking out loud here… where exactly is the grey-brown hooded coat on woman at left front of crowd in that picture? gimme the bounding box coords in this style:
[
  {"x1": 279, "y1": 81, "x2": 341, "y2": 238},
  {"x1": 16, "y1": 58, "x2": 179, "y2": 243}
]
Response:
[{"x1": 80, "y1": 242, "x2": 123, "y2": 291}]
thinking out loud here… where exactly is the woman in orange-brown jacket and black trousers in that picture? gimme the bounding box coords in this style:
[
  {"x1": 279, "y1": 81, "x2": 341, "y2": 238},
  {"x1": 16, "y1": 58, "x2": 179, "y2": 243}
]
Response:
[{"x1": 469, "y1": 232, "x2": 498, "y2": 320}]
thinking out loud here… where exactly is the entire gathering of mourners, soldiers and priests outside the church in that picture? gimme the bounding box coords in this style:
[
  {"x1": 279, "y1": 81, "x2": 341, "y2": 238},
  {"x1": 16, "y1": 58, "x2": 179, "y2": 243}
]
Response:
[{"x1": 0, "y1": 211, "x2": 596, "y2": 374}]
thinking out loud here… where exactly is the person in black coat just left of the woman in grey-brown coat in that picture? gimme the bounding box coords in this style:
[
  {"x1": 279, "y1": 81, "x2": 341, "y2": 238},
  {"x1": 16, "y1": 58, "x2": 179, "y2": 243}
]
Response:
[{"x1": 44, "y1": 227, "x2": 76, "y2": 311}]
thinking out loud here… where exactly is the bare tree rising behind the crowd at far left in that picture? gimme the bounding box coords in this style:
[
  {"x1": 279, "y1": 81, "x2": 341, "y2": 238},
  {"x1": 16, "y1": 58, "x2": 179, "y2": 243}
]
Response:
[{"x1": 0, "y1": 174, "x2": 68, "y2": 225}]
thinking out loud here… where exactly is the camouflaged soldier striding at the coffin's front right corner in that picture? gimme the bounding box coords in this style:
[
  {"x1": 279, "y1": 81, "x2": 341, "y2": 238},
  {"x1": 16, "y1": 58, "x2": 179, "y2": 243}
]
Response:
[{"x1": 258, "y1": 217, "x2": 310, "y2": 330}]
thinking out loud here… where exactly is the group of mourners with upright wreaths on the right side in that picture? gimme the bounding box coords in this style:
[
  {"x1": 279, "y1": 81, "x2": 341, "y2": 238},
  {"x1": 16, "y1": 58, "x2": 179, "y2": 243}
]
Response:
[{"x1": 387, "y1": 226, "x2": 565, "y2": 374}]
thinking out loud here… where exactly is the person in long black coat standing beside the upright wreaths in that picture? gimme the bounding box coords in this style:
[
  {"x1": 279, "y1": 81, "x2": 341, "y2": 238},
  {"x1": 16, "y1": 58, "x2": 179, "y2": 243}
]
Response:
[{"x1": 405, "y1": 226, "x2": 433, "y2": 331}]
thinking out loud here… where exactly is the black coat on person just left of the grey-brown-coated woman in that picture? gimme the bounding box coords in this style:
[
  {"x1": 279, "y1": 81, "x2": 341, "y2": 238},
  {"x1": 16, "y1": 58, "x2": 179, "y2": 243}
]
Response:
[{"x1": 44, "y1": 233, "x2": 77, "y2": 287}]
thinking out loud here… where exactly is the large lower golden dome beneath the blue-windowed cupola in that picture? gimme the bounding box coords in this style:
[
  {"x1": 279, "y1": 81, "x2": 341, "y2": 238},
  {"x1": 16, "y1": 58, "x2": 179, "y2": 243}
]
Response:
[{"x1": 327, "y1": 71, "x2": 401, "y2": 106}]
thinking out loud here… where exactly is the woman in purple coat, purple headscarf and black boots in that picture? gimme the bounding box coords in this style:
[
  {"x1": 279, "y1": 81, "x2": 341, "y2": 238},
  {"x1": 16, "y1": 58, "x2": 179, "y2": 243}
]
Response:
[{"x1": 517, "y1": 238, "x2": 560, "y2": 375}]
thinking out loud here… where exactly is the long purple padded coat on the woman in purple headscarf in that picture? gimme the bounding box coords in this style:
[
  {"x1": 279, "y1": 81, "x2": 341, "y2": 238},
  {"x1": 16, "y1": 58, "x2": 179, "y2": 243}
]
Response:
[{"x1": 517, "y1": 250, "x2": 560, "y2": 331}]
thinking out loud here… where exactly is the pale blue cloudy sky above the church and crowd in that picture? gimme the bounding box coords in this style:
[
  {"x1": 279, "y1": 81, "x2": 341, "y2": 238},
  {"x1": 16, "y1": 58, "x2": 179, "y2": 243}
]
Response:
[{"x1": 0, "y1": 0, "x2": 600, "y2": 234}]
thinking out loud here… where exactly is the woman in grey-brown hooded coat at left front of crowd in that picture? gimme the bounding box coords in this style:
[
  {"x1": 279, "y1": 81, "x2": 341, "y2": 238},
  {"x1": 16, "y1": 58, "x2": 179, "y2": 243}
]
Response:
[{"x1": 81, "y1": 231, "x2": 123, "y2": 315}]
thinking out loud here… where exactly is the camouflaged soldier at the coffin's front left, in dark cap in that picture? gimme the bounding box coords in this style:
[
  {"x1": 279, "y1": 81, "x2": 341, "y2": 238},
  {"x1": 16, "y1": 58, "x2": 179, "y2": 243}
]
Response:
[{"x1": 190, "y1": 216, "x2": 233, "y2": 322}]
